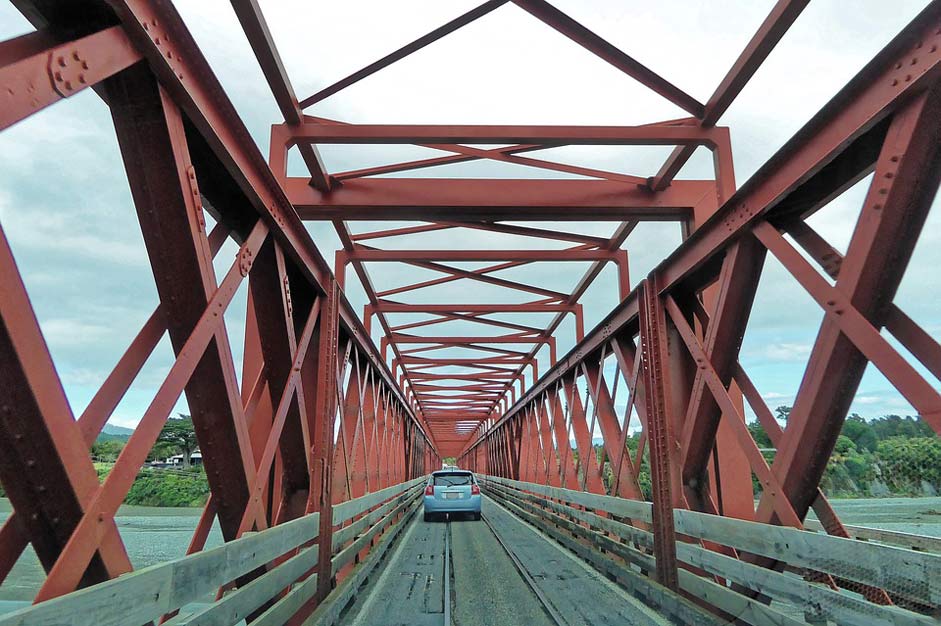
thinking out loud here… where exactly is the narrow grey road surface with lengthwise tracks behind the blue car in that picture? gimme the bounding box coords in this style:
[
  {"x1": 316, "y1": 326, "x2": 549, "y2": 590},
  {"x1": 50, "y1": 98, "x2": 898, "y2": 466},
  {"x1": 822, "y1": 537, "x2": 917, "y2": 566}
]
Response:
[{"x1": 341, "y1": 498, "x2": 669, "y2": 626}]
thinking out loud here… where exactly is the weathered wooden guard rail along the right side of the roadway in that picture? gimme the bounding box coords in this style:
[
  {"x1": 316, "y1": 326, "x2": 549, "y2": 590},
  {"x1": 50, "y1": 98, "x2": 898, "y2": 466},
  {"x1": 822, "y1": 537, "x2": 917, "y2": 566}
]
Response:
[{"x1": 482, "y1": 476, "x2": 941, "y2": 626}]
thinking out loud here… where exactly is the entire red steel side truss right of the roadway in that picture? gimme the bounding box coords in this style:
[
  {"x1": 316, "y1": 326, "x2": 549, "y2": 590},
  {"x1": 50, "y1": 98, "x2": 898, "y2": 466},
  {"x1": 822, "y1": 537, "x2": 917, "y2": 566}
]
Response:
[{"x1": 460, "y1": 2, "x2": 941, "y2": 603}]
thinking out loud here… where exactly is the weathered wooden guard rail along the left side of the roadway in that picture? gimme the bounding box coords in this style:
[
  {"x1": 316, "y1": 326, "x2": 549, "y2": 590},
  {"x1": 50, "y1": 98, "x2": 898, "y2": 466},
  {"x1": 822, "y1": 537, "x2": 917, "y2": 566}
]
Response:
[{"x1": 0, "y1": 476, "x2": 427, "y2": 626}]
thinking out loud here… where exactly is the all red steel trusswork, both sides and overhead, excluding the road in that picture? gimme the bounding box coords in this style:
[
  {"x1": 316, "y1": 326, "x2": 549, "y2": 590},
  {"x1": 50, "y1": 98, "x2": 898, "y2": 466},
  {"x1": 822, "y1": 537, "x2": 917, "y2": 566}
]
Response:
[{"x1": 0, "y1": 0, "x2": 941, "y2": 623}]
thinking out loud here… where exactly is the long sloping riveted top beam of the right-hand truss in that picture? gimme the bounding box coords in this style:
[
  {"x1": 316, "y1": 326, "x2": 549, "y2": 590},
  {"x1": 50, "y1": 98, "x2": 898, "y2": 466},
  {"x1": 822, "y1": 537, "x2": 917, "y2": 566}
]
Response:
[{"x1": 460, "y1": 2, "x2": 941, "y2": 449}]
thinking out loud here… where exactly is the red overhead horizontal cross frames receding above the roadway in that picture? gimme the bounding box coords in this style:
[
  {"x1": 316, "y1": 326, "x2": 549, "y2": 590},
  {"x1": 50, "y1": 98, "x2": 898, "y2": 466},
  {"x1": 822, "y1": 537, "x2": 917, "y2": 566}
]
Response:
[{"x1": 259, "y1": 62, "x2": 734, "y2": 456}]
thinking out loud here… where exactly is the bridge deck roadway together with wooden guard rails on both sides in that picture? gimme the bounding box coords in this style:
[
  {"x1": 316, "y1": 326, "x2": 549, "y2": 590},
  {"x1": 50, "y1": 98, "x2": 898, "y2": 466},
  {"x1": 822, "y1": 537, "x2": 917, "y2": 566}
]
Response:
[{"x1": 0, "y1": 475, "x2": 941, "y2": 626}]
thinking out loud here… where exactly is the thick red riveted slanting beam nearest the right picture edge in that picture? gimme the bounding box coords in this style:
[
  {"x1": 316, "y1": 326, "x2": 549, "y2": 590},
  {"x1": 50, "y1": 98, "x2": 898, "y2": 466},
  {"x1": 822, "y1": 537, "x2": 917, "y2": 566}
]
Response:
[{"x1": 756, "y1": 86, "x2": 941, "y2": 520}]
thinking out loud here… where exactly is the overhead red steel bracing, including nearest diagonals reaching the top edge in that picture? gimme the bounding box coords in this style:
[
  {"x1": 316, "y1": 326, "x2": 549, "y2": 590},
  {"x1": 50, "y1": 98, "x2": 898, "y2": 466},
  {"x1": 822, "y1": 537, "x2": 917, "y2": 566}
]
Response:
[{"x1": 255, "y1": 1, "x2": 748, "y2": 456}]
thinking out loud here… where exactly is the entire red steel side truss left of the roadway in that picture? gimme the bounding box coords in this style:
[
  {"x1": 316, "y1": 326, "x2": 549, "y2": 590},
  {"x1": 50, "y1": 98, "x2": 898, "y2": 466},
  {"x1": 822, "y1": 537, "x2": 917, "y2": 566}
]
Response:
[{"x1": 0, "y1": 1, "x2": 439, "y2": 611}]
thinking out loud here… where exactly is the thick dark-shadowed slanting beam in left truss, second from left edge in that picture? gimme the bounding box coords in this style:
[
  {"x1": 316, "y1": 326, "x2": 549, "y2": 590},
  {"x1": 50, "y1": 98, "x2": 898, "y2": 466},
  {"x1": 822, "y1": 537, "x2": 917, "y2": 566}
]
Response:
[{"x1": 108, "y1": 66, "x2": 252, "y2": 539}]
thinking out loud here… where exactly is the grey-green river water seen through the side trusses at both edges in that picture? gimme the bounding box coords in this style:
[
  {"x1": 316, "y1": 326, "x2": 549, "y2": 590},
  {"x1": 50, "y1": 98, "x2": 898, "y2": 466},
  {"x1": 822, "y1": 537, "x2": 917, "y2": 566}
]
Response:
[{"x1": 0, "y1": 497, "x2": 941, "y2": 613}]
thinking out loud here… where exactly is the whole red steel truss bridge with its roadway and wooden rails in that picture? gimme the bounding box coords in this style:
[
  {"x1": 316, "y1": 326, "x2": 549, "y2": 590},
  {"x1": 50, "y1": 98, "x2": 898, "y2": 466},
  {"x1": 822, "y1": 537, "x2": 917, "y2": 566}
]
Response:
[{"x1": 0, "y1": 0, "x2": 941, "y2": 626}]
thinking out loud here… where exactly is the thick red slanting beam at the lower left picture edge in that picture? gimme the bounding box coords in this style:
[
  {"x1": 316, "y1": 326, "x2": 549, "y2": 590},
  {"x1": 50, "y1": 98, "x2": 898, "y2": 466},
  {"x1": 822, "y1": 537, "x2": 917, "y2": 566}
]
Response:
[{"x1": 0, "y1": 223, "x2": 132, "y2": 591}]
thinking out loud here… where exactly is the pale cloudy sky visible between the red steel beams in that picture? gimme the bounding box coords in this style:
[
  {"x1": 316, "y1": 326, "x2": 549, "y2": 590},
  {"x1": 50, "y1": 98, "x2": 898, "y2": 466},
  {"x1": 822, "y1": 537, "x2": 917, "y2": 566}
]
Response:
[{"x1": 0, "y1": 0, "x2": 941, "y2": 426}]
